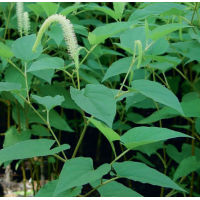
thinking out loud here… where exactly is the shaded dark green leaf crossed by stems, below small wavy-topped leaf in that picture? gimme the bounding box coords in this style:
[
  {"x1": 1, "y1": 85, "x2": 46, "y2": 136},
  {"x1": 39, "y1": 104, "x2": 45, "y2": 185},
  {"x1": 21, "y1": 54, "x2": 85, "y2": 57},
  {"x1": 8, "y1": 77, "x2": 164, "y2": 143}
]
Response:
[{"x1": 27, "y1": 110, "x2": 73, "y2": 132}]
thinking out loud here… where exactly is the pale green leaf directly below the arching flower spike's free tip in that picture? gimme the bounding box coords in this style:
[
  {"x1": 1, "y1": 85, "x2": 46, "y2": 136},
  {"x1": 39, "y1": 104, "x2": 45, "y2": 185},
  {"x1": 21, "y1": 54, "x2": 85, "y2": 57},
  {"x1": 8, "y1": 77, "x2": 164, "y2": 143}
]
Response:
[{"x1": 27, "y1": 57, "x2": 64, "y2": 72}]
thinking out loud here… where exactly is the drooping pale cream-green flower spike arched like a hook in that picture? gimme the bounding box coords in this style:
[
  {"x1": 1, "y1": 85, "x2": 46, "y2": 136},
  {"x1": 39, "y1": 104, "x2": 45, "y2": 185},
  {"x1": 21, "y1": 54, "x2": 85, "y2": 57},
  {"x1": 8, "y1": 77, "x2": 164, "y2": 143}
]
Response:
[{"x1": 32, "y1": 14, "x2": 78, "y2": 60}]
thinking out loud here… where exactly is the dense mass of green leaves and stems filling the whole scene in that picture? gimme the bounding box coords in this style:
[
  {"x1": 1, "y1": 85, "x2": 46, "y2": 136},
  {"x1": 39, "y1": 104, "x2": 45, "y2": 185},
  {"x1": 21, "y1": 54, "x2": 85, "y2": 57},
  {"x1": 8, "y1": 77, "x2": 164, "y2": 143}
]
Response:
[{"x1": 0, "y1": 2, "x2": 200, "y2": 197}]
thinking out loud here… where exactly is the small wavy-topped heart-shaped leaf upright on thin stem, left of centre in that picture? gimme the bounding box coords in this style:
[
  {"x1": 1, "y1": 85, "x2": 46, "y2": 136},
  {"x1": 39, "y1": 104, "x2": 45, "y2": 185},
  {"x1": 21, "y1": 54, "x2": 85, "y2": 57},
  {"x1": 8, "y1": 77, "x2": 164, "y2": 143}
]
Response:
[{"x1": 31, "y1": 95, "x2": 65, "y2": 111}]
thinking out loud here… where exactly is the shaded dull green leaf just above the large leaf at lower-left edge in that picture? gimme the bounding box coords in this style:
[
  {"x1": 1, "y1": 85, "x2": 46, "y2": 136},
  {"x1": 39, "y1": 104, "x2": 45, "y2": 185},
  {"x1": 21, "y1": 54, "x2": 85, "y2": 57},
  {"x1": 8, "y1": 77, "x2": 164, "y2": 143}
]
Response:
[{"x1": 3, "y1": 126, "x2": 31, "y2": 148}]
